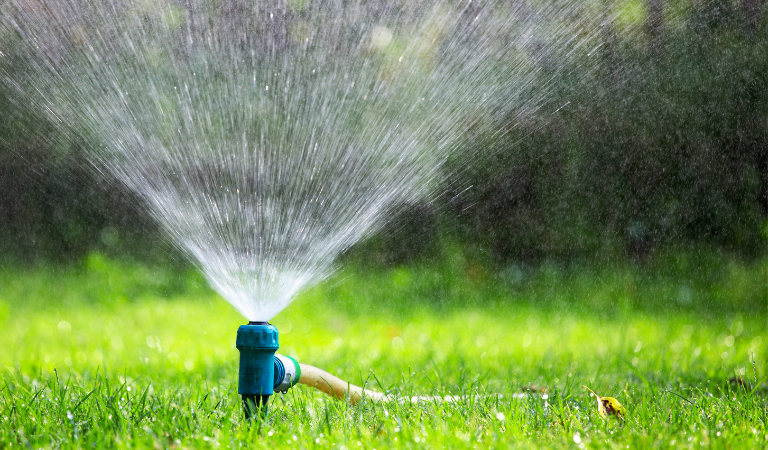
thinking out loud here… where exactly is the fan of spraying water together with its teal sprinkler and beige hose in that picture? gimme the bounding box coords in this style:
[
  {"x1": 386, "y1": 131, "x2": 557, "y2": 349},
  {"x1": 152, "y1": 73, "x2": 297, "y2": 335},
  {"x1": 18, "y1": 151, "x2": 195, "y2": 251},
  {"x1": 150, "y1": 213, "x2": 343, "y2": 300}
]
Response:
[{"x1": 0, "y1": 0, "x2": 600, "y2": 417}]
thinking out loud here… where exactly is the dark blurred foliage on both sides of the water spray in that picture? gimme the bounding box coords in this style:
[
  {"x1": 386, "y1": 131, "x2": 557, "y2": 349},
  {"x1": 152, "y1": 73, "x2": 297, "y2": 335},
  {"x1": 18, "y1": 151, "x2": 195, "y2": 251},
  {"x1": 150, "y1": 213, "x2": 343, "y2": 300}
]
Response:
[{"x1": 0, "y1": 0, "x2": 768, "y2": 268}]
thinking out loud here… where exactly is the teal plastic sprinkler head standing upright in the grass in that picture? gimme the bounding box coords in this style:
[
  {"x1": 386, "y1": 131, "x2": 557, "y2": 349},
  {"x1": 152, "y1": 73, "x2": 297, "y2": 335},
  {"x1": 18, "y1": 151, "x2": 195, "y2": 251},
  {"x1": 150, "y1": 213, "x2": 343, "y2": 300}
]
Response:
[{"x1": 235, "y1": 322, "x2": 301, "y2": 420}]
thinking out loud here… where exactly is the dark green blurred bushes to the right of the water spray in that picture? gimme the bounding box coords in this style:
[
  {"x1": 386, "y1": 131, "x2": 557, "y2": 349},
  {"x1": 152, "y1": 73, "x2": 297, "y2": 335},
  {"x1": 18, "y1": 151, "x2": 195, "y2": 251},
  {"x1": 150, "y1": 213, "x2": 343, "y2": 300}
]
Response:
[{"x1": 448, "y1": 2, "x2": 768, "y2": 260}]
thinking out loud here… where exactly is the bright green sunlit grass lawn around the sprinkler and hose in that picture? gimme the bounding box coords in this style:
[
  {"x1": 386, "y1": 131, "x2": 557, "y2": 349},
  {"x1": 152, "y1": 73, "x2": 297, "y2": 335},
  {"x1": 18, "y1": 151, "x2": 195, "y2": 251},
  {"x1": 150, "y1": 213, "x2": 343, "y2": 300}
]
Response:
[{"x1": 0, "y1": 254, "x2": 768, "y2": 449}]
